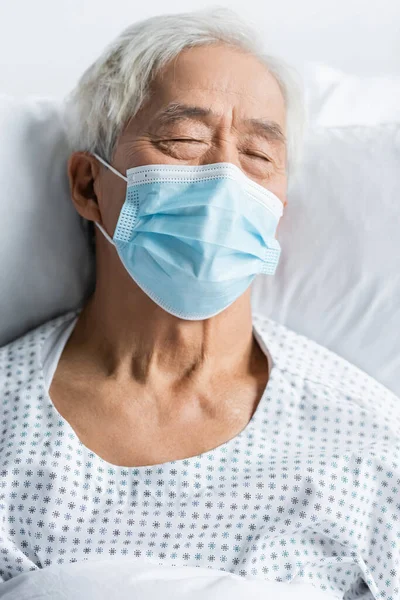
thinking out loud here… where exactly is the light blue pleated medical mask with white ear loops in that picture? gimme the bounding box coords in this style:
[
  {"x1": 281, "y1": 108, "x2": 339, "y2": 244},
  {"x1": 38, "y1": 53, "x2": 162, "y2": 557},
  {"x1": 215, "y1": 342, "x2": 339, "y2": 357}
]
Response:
[{"x1": 95, "y1": 154, "x2": 283, "y2": 320}]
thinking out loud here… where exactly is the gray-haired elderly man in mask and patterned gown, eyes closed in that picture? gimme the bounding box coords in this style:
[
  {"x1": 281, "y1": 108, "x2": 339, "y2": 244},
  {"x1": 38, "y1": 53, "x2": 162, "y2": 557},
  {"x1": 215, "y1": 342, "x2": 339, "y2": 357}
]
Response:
[{"x1": 0, "y1": 5, "x2": 400, "y2": 600}]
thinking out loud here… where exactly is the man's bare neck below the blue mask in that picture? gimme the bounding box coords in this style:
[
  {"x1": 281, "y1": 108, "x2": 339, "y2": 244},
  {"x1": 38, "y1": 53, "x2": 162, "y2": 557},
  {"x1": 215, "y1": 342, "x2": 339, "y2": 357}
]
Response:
[{"x1": 64, "y1": 247, "x2": 254, "y2": 383}]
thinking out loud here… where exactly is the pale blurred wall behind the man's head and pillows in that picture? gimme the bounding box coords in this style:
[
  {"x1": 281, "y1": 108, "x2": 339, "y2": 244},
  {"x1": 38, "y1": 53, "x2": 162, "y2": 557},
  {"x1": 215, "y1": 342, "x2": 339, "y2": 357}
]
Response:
[{"x1": 0, "y1": 0, "x2": 400, "y2": 96}]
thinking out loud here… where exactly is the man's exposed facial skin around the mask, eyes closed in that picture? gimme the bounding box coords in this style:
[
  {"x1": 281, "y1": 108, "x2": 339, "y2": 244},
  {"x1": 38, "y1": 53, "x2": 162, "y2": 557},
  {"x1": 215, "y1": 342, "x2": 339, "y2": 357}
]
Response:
[{"x1": 97, "y1": 46, "x2": 287, "y2": 234}]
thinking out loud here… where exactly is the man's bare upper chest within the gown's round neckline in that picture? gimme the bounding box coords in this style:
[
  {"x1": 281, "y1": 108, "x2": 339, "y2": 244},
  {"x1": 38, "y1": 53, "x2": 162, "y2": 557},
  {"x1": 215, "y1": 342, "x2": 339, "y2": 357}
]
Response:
[{"x1": 50, "y1": 379, "x2": 266, "y2": 467}]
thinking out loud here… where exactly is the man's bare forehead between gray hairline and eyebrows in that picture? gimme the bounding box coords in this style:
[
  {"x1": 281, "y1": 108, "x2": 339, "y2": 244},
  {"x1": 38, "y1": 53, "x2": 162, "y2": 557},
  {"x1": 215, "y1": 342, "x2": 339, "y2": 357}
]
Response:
[{"x1": 151, "y1": 45, "x2": 285, "y2": 132}]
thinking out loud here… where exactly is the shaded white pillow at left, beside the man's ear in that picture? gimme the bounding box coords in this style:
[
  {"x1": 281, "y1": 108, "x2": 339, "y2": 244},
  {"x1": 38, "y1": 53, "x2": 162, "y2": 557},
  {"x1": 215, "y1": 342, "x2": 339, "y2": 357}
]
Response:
[{"x1": 0, "y1": 95, "x2": 93, "y2": 346}]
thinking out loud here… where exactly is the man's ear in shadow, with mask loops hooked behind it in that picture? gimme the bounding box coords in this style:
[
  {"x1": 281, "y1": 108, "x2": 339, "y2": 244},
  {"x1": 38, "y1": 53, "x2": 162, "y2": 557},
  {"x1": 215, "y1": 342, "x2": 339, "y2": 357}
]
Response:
[{"x1": 68, "y1": 152, "x2": 101, "y2": 223}]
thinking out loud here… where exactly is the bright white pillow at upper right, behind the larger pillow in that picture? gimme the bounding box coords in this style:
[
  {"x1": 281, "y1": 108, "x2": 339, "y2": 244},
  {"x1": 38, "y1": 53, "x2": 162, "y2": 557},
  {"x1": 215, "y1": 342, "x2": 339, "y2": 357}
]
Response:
[{"x1": 298, "y1": 63, "x2": 400, "y2": 127}]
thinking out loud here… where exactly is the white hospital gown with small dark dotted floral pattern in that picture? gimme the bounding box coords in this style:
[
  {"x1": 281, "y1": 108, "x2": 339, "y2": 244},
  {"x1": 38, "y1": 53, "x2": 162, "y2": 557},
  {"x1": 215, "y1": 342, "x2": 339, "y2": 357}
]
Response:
[{"x1": 0, "y1": 311, "x2": 400, "y2": 600}]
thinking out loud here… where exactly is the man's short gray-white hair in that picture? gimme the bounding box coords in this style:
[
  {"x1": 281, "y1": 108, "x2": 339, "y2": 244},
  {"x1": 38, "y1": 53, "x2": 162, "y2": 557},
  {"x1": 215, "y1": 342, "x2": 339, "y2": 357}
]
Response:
[{"x1": 65, "y1": 8, "x2": 306, "y2": 183}]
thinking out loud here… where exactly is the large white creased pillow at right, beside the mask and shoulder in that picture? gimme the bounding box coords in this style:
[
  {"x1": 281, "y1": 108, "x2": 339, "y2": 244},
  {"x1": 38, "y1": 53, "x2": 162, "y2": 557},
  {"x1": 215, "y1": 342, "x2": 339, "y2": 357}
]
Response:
[{"x1": 253, "y1": 124, "x2": 400, "y2": 395}]
